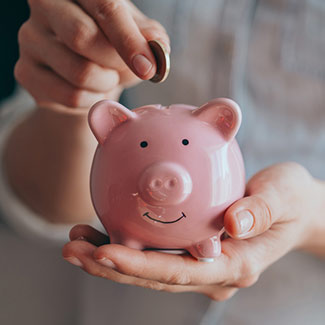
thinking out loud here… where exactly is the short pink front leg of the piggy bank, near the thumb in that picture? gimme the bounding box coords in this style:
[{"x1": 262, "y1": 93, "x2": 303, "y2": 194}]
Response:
[{"x1": 188, "y1": 235, "x2": 221, "y2": 262}]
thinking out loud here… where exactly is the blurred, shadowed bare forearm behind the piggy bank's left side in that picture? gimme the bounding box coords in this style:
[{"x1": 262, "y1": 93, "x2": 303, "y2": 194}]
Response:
[{"x1": 5, "y1": 104, "x2": 96, "y2": 223}]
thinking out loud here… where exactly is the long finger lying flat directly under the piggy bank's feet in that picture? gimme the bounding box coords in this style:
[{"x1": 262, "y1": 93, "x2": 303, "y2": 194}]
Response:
[{"x1": 94, "y1": 245, "x2": 229, "y2": 286}]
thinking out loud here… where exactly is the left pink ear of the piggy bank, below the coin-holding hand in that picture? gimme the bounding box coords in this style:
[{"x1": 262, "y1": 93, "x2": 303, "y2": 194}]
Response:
[{"x1": 88, "y1": 100, "x2": 137, "y2": 144}]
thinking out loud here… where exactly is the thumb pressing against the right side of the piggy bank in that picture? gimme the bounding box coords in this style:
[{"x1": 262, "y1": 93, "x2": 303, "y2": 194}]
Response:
[{"x1": 224, "y1": 162, "x2": 312, "y2": 239}]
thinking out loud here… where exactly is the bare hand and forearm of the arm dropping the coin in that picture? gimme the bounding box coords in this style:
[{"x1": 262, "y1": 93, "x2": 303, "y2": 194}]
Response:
[{"x1": 9, "y1": 0, "x2": 170, "y2": 223}]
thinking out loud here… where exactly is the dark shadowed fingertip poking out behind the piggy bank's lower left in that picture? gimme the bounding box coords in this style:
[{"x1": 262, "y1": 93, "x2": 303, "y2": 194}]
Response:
[{"x1": 69, "y1": 225, "x2": 109, "y2": 246}]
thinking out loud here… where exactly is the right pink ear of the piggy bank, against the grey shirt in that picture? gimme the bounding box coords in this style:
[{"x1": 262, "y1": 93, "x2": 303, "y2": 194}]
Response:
[{"x1": 193, "y1": 98, "x2": 241, "y2": 142}]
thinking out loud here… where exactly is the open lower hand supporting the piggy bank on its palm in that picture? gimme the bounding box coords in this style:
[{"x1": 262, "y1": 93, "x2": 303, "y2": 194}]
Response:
[{"x1": 63, "y1": 163, "x2": 321, "y2": 300}]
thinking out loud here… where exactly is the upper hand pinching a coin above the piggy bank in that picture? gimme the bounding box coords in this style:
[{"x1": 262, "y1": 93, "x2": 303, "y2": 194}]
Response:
[{"x1": 15, "y1": 0, "x2": 169, "y2": 107}]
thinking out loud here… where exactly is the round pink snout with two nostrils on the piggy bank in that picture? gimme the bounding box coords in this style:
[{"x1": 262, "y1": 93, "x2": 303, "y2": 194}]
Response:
[{"x1": 138, "y1": 162, "x2": 192, "y2": 205}]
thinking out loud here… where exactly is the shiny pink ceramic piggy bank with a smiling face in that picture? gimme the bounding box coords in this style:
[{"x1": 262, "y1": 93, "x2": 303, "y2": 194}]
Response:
[{"x1": 89, "y1": 98, "x2": 245, "y2": 261}]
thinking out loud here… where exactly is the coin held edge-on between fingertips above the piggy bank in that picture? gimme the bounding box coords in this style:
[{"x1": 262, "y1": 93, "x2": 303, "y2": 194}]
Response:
[{"x1": 148, "y1": 40, "x2": 170, "y2": 83}]
